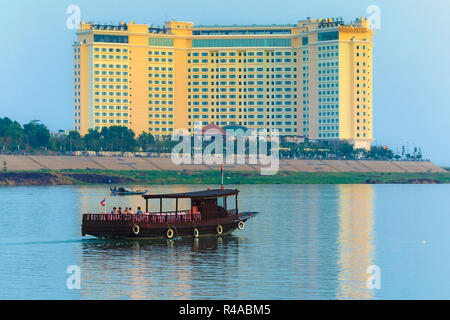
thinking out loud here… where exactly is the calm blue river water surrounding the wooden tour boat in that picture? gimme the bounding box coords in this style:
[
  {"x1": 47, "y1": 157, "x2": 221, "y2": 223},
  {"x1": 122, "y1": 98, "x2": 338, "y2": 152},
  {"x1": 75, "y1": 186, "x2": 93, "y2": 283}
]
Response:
[{"x1": 0, "y1": 184, "x2": 450, "y2": 299}]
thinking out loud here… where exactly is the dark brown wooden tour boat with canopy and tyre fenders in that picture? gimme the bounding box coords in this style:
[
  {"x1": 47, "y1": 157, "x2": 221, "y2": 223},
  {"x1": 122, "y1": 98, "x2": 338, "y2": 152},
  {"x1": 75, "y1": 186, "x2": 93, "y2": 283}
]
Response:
[{"x1": 81, "y1": 189, "x2": 258, "y2": 239}]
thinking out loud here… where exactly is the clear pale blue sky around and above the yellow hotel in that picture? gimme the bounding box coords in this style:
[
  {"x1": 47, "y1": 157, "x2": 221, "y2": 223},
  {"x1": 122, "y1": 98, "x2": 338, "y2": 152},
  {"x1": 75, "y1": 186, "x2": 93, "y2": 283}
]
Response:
[{"x1": 0, "y1": 0, "x2": 450, "y2": 166}]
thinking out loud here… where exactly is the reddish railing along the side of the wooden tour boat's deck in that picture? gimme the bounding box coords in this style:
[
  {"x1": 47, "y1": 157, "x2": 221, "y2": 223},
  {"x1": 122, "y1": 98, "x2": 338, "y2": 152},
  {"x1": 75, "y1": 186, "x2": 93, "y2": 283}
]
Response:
[{"x1": 83, "y1": 211, "x2": 201, "y2": 223}]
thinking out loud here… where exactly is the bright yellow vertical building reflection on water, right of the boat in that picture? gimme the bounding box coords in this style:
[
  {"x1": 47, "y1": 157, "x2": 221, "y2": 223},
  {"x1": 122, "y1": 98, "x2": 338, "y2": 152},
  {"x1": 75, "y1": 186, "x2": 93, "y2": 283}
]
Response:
[{"x1": 337, "y1": 184, "x2": 375, "y2": 299}]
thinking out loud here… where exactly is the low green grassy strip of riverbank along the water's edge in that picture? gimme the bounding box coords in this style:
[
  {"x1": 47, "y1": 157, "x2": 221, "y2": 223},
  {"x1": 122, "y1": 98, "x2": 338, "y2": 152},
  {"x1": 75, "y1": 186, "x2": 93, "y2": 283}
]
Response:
[{"x1": 0, "y1": 170, "x2": 450, "y2": 186}]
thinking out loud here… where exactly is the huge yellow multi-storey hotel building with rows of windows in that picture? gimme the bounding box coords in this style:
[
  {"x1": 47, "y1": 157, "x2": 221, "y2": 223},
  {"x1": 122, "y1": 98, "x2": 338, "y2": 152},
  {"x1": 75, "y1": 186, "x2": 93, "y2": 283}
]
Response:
[{"x1": 73, "y1": 18, "x2": 373, "y2": 148}]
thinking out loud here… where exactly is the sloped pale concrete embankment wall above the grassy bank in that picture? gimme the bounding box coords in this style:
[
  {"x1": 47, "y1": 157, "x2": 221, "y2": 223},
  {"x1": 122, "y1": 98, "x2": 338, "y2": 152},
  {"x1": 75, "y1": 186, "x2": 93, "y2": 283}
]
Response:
[{"x1": 0, "y1": 155, "x2": 447, "y2": 173}]
